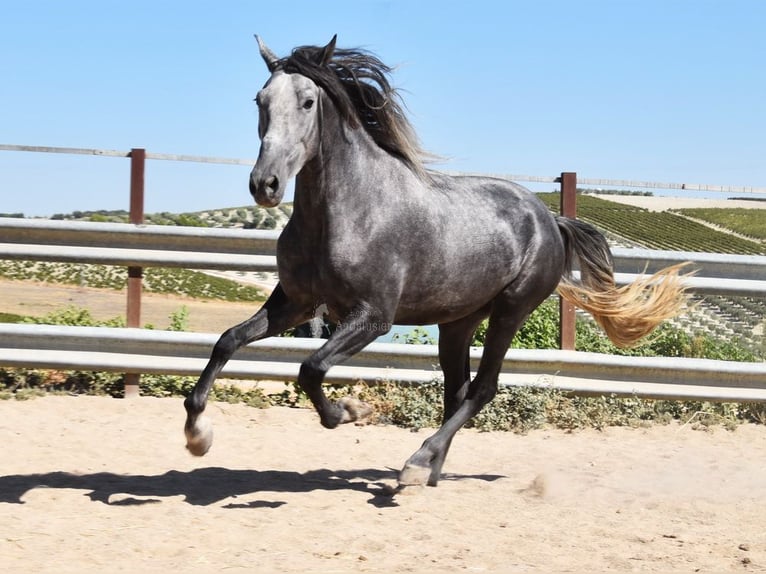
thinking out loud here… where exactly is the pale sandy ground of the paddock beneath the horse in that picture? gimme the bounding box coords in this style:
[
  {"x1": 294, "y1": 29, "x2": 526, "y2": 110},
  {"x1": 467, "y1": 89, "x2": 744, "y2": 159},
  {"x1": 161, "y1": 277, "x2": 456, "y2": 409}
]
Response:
[{"x1": 0, "y1": 397, "x2": 766, "y2": 573}]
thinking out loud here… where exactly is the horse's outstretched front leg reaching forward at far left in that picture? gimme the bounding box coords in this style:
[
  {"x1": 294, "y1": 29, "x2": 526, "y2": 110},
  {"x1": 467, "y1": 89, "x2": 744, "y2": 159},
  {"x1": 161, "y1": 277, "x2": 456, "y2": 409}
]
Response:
[{"x1": 184, "y1": 284, "x2": 311, "y2": 456}]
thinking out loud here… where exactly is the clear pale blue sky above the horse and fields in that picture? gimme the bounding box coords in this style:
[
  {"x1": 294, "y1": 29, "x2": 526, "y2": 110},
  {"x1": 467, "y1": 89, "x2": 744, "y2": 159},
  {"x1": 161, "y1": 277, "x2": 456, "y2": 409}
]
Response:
[{"x1": 0, "y1": 0, "x2": 766, "y2": 216}]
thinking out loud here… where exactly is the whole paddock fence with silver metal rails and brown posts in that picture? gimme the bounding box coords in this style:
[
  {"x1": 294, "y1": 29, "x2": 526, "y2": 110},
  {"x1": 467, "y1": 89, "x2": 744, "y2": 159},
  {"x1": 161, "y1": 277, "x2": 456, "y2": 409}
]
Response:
[{"x1": 0, "y1": 145, "x2": 766, "y2": 401}]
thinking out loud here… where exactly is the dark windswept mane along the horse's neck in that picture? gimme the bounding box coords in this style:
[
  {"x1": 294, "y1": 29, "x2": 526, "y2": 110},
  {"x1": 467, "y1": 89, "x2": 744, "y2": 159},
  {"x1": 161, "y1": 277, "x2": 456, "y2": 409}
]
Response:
[{"x1": 277, "y1": 46, "x2": 427, "y2": 177}]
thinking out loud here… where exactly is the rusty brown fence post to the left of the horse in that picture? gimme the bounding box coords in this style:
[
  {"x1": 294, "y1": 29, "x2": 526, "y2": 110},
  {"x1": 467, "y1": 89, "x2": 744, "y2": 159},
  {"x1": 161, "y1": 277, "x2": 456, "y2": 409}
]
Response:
[{"x1": 125, "y1": 148, "x2": 146, "y2": 398}]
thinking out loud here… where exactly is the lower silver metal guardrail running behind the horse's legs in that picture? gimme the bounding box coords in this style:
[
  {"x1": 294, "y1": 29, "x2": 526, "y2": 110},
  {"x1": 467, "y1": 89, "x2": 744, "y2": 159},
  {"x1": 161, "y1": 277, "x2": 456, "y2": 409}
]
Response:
[{"x1": 0, "y1": 324, "x2": 766, "y2": 401}]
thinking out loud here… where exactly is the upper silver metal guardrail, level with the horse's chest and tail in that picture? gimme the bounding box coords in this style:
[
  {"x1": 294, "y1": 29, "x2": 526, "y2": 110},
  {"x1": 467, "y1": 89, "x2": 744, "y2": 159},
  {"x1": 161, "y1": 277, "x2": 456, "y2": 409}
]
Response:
[{"x1": 0, "y1": 218, "x2": 766, "y2": 296}]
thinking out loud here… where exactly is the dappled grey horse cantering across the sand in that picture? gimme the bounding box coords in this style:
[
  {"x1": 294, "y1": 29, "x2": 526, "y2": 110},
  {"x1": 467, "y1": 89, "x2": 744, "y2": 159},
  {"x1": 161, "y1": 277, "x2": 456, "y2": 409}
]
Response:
[{"x1": 184, "y1": 36, "x2": 686, "y2": 488}]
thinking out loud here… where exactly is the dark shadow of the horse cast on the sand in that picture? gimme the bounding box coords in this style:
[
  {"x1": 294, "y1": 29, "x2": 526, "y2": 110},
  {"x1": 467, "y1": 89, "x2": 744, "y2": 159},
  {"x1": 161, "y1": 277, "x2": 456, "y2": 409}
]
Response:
[{"x1": 0, "y1": 467, "x2": 502, "y2": 508}]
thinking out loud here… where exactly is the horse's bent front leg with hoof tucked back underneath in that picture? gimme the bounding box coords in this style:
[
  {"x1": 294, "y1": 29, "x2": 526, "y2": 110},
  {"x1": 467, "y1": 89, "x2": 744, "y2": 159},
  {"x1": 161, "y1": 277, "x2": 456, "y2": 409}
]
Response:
[{"x1": 298, "y1": 307, "x2": 391, "y2": 428}]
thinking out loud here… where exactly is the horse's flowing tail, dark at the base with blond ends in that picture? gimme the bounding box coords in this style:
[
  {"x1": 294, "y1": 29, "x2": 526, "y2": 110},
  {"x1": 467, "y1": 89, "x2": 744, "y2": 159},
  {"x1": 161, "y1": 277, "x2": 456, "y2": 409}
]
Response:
[{"x1": 556, "y1": 217, "x2": 688, "y2": 347}]
